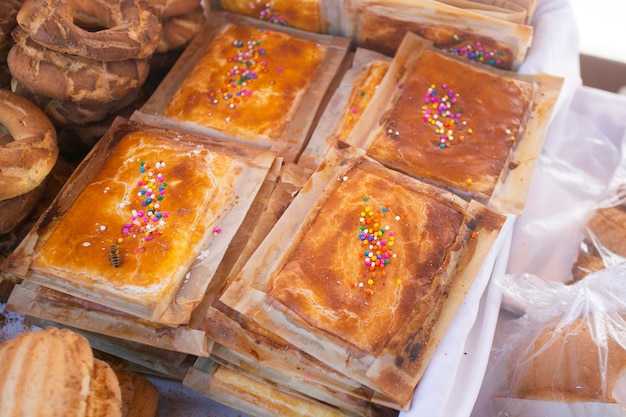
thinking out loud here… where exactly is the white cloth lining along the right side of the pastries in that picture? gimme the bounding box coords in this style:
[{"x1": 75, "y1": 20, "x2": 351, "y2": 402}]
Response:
[{"x1": 400, "y1": 0, "x2": 580, "y2": 417}]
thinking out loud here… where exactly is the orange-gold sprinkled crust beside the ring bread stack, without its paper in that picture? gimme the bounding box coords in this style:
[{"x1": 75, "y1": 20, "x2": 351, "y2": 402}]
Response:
[{"x1": 163, "y1": 24, "x2": 326, "y2": 142}]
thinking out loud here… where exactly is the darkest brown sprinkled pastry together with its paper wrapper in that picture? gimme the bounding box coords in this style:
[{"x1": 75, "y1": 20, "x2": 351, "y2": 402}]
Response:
[{"x1": 348, "y1": 33, "x2": 562, "y2": 214}]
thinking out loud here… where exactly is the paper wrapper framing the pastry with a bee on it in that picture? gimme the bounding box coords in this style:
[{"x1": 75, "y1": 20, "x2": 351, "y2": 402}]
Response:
[{"x1": 3, "y1": 119, "x2": 275, "y2": 325}]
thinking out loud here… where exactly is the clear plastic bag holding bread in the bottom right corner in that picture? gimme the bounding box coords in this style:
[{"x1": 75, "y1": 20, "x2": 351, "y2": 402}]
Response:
[{"x1": 492, "y1": 265, "x2": 626, "y2": 417}]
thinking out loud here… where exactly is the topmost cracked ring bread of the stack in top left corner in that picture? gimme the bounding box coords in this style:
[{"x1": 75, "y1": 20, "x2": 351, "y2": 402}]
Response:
[{"x1": 17, "y1": 0, "x2": 161, "y2": 61}]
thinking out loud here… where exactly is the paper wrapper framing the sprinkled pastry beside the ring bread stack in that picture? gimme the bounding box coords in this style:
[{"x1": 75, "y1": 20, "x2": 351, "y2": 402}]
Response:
[{"x1": 133, "y1": 11, "x2": 349, "y2": 162}]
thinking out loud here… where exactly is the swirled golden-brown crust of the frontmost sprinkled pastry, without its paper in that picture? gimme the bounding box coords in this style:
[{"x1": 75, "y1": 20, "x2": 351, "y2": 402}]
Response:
[{"x1": 268, "y1": 156, "x2": 464, "y2": 356}]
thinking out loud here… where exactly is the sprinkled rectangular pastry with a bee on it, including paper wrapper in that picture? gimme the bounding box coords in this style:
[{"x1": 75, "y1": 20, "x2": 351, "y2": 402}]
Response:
[{"x1": 1, "y1": 119, "x2": 275, "y2": 325}]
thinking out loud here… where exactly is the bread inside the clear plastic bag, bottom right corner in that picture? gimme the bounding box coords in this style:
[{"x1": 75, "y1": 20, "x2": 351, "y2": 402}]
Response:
[{"x1": 511, "y1": 320, "x2": 626, "y2": 403}]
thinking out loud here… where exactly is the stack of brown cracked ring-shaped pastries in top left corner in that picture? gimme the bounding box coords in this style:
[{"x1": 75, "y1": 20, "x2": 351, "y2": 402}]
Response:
[{"x1": 8, "y1": 0, "x2": 161, "y2": 150}]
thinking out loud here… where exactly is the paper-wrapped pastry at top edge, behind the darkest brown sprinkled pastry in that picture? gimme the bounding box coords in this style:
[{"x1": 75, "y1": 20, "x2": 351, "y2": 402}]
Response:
[{"x1": 346, "y1": 0, "x2": 533, "y2": 69}]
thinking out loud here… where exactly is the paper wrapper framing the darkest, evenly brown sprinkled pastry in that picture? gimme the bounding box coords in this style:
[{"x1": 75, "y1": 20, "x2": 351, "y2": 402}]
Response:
[{"x1": 347, "y1": 33, "x2": 562, "y2": 214}]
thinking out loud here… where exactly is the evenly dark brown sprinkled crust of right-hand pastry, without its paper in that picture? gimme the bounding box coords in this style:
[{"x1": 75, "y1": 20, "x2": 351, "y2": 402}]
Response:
[{"x1": 368, "y1": 50, "x2": 534, "y2": 196}]
